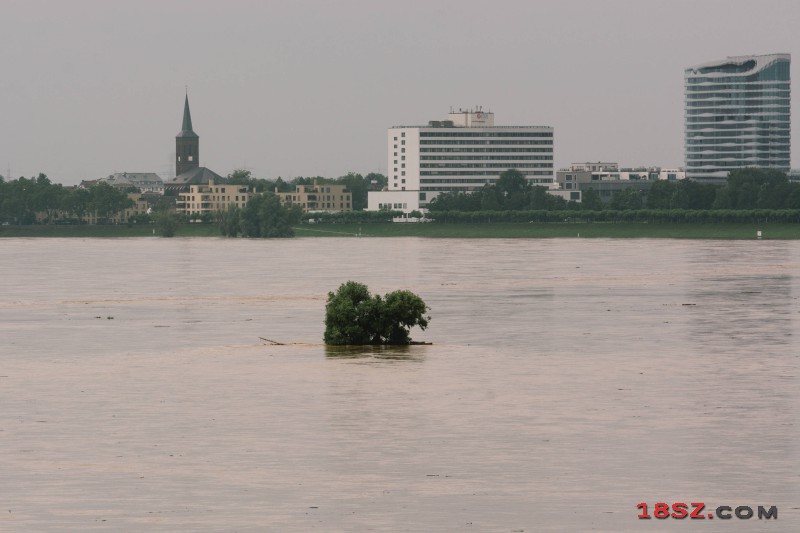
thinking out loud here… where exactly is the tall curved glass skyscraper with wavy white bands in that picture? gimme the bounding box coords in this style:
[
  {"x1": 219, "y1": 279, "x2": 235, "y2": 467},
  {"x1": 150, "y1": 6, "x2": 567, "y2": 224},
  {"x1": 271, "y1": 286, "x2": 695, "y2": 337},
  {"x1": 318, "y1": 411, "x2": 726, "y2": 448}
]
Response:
[{"x1": 684, "y1": 54, "x2": 791, "y2": 182}]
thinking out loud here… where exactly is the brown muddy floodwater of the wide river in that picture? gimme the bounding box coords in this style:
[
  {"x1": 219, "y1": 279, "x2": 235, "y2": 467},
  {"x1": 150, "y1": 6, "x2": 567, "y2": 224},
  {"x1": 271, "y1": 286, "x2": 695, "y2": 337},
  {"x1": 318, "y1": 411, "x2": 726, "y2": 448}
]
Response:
[{"x1": 0, "y1": 238, "x2": 800, "y2": 532}]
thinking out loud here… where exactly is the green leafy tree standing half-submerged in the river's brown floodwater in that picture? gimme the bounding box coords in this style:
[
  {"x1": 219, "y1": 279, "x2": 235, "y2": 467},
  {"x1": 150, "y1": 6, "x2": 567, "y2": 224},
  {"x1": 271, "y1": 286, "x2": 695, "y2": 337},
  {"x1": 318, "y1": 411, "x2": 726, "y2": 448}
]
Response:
[{"x1": 323, "y1": 281, "x2": 430, "y2": 345}]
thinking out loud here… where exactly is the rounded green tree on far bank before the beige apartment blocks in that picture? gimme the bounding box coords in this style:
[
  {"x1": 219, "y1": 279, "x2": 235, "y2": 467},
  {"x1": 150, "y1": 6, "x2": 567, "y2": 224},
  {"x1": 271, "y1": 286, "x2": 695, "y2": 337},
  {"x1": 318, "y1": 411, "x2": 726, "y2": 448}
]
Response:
[{"x1": 239, "y1": 192, "x2": 303, "y2": 238}]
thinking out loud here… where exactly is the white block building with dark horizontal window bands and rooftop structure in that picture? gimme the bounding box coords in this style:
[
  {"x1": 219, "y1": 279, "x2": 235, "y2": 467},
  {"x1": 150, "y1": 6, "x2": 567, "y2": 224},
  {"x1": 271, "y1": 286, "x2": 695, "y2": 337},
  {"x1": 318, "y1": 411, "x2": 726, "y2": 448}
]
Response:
[{"x1": 384, "y1": 108, "x2": 554, "y2": 209}]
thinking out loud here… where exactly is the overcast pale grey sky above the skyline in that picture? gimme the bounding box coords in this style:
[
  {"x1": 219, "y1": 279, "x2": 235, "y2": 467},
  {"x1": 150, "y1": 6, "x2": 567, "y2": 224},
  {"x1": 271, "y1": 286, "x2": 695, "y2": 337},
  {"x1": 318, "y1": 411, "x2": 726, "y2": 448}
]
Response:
[{"x1": 0, "y1": 0, "x2": 800, "y2": 184}]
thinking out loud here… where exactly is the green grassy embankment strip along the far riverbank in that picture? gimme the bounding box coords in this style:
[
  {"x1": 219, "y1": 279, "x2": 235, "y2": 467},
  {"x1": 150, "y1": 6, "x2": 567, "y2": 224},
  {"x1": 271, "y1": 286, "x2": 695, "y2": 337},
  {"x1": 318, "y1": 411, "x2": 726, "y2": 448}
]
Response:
[{"x1": 0, "y1": 222, "x2": 800, "y2": 239}]
